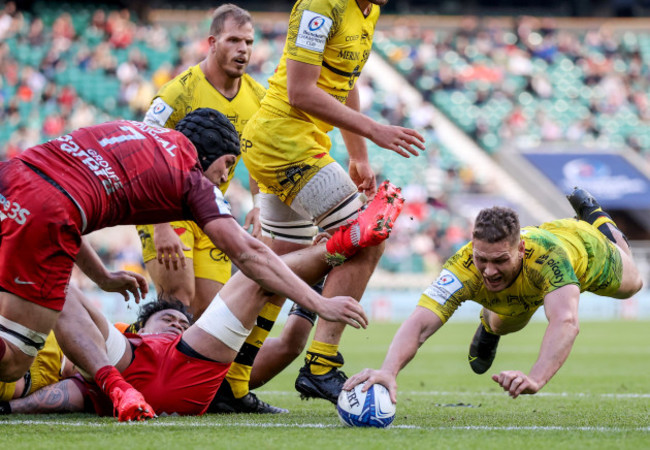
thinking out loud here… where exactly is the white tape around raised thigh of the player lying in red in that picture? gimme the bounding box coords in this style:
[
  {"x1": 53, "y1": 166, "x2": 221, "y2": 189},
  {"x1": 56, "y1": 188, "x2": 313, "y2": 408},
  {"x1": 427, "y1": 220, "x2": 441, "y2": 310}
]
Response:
[{"x1": 195, "y1": 294, "x2": 251, "y2": 352}]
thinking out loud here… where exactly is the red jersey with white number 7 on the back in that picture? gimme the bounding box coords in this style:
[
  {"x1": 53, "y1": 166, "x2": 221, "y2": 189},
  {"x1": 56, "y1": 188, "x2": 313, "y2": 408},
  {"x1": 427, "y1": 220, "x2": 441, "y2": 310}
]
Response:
[{"x1": 16, "y1": 120, "x2": 230, "y2": 234}]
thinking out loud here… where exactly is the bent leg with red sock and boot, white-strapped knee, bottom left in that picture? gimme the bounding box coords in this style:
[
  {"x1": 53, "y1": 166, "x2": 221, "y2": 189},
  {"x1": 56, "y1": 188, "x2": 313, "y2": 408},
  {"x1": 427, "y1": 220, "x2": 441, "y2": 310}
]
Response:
[{"x1": 54, "y1": 286, "x2": 154, "y2": 421}]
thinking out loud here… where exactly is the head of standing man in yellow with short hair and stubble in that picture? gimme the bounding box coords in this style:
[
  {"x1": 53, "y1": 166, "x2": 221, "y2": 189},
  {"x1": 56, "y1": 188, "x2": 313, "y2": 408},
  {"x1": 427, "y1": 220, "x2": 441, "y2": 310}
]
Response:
[{"x1": 207, "y1": 3, "x2": 255, "y2": 78}]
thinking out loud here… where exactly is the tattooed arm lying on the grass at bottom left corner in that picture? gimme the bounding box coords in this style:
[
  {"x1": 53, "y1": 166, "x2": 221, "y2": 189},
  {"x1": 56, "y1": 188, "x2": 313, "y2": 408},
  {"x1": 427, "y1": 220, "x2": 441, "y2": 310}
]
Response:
[{"x1": 11, "y1": 380, "x2": 84, "y2": 414}]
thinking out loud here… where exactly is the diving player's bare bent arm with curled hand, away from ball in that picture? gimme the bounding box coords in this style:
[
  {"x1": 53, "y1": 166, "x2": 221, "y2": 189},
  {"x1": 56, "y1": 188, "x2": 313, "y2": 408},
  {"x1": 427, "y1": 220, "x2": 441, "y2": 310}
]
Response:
[{"x1": 492, "y1": 284, "x2": 580, "y2": 398}]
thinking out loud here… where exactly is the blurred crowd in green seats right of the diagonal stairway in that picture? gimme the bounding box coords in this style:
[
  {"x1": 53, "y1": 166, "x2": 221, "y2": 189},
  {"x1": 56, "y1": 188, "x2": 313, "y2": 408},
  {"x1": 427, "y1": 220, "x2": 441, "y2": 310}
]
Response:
[{"x1": 375, "y1": 17, "x2": 650, "y2": 158}]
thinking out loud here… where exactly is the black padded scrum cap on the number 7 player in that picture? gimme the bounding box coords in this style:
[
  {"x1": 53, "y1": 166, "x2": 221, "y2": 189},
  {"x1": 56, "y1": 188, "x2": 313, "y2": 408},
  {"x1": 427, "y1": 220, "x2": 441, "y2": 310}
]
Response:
[{"x1": 176, "y1": 108, "x2": 240, "y2": 171}]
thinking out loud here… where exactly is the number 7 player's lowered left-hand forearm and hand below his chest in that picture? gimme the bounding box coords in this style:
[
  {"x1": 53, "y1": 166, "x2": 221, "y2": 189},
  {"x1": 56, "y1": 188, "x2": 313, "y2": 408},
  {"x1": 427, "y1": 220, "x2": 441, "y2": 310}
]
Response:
[{"x1": 75, "y1": 237, "x2": 149, "y2": 303}]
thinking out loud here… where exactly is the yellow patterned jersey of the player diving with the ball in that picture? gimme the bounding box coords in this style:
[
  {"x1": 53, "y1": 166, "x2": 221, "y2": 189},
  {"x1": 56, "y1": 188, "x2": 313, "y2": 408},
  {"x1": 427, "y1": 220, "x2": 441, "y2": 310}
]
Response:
[{"x1": 418, "y1": 219, "x2": 623, "y2": 323}]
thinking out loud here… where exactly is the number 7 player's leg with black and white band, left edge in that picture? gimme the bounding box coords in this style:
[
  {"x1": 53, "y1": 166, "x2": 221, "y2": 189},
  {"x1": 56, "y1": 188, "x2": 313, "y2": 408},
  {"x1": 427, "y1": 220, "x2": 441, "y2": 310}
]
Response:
[{"x1": 0, "y1": 292, "x2": 59, "y2": 382}]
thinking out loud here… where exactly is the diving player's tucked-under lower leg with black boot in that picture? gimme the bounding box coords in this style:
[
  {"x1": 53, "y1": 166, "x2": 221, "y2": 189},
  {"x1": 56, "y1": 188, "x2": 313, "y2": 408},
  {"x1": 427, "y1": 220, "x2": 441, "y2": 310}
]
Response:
[{"x1": 467, "y1": 308, "x2": 534, "y2": 375}]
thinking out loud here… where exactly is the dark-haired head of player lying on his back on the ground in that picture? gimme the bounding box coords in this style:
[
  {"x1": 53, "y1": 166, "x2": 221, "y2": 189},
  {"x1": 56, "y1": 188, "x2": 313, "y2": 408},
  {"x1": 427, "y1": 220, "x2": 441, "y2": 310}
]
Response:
[{"x1": 126, "y1": 295, "x2": 192, "y2": 334}]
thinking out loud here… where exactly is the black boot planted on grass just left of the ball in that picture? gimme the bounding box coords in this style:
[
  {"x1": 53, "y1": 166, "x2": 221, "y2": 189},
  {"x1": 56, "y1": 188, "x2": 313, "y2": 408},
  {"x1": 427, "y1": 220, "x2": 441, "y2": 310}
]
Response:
[{"x1": 295, "y1": 352, "x2": 348, "y2": 405}]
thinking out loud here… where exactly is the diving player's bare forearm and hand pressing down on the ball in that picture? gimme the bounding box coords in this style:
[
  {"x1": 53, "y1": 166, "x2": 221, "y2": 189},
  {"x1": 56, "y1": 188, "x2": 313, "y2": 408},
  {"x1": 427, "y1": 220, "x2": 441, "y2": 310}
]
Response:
[{"x1": 343, "y1": 306, "x2": 443, "y2": 403}]
